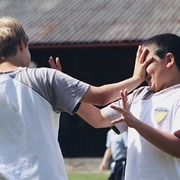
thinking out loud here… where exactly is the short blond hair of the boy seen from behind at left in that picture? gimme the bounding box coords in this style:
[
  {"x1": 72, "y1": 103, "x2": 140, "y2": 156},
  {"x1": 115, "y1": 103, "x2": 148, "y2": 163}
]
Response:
[{"x1": 0, "y1": 17, "x2": 29, "y2": 60}]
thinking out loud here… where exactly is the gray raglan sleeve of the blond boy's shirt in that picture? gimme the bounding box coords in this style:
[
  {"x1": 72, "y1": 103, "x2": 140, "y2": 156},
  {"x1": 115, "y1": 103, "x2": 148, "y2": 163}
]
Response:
[{"x1": 24, "y1": 68, "x2": 90, "y2": 114}]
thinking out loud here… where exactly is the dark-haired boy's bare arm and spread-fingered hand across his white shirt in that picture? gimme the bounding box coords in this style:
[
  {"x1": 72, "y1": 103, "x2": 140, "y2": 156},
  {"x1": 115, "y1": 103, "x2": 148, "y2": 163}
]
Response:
[{"x1": 111, "y1": 90, "x2": 180, "y2": 158}]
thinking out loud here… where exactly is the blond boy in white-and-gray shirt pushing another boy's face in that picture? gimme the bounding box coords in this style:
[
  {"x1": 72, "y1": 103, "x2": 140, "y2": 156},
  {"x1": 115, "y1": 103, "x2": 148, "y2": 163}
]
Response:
[{"x1": 0, "y1": 17, "x2": 148, "y2": 180}]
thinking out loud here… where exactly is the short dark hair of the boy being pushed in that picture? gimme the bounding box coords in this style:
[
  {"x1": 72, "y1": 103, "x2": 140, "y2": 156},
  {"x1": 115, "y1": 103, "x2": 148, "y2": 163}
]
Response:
[{"x1": 143, "y1": 33, "x2": 180, "y2": 69}]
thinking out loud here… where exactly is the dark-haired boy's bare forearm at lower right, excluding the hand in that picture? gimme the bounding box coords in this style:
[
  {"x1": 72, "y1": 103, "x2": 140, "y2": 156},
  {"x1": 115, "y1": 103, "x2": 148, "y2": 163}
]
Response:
[{"x1": 133, "y1": 117, "x2": 180, "y2": 158}]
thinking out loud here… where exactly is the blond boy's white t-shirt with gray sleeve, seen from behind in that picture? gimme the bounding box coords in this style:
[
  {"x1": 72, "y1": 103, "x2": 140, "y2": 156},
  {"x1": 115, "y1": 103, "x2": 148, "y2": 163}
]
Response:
[{"x1": 0, "y1": 68, "x2": 89, "y2": 180}]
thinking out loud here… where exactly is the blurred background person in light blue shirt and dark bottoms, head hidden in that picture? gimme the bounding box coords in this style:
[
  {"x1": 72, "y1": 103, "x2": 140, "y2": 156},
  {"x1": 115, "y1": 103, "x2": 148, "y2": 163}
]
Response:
[{"x1": 99, "y1": 129, "x2": 127, "y2": 180}]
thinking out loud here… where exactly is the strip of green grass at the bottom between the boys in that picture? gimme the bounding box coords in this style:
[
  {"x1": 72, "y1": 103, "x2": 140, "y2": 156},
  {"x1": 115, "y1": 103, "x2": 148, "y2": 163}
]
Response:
[{"x1": 68, "y1": 172, "x2": 108, "y2": 180}]
